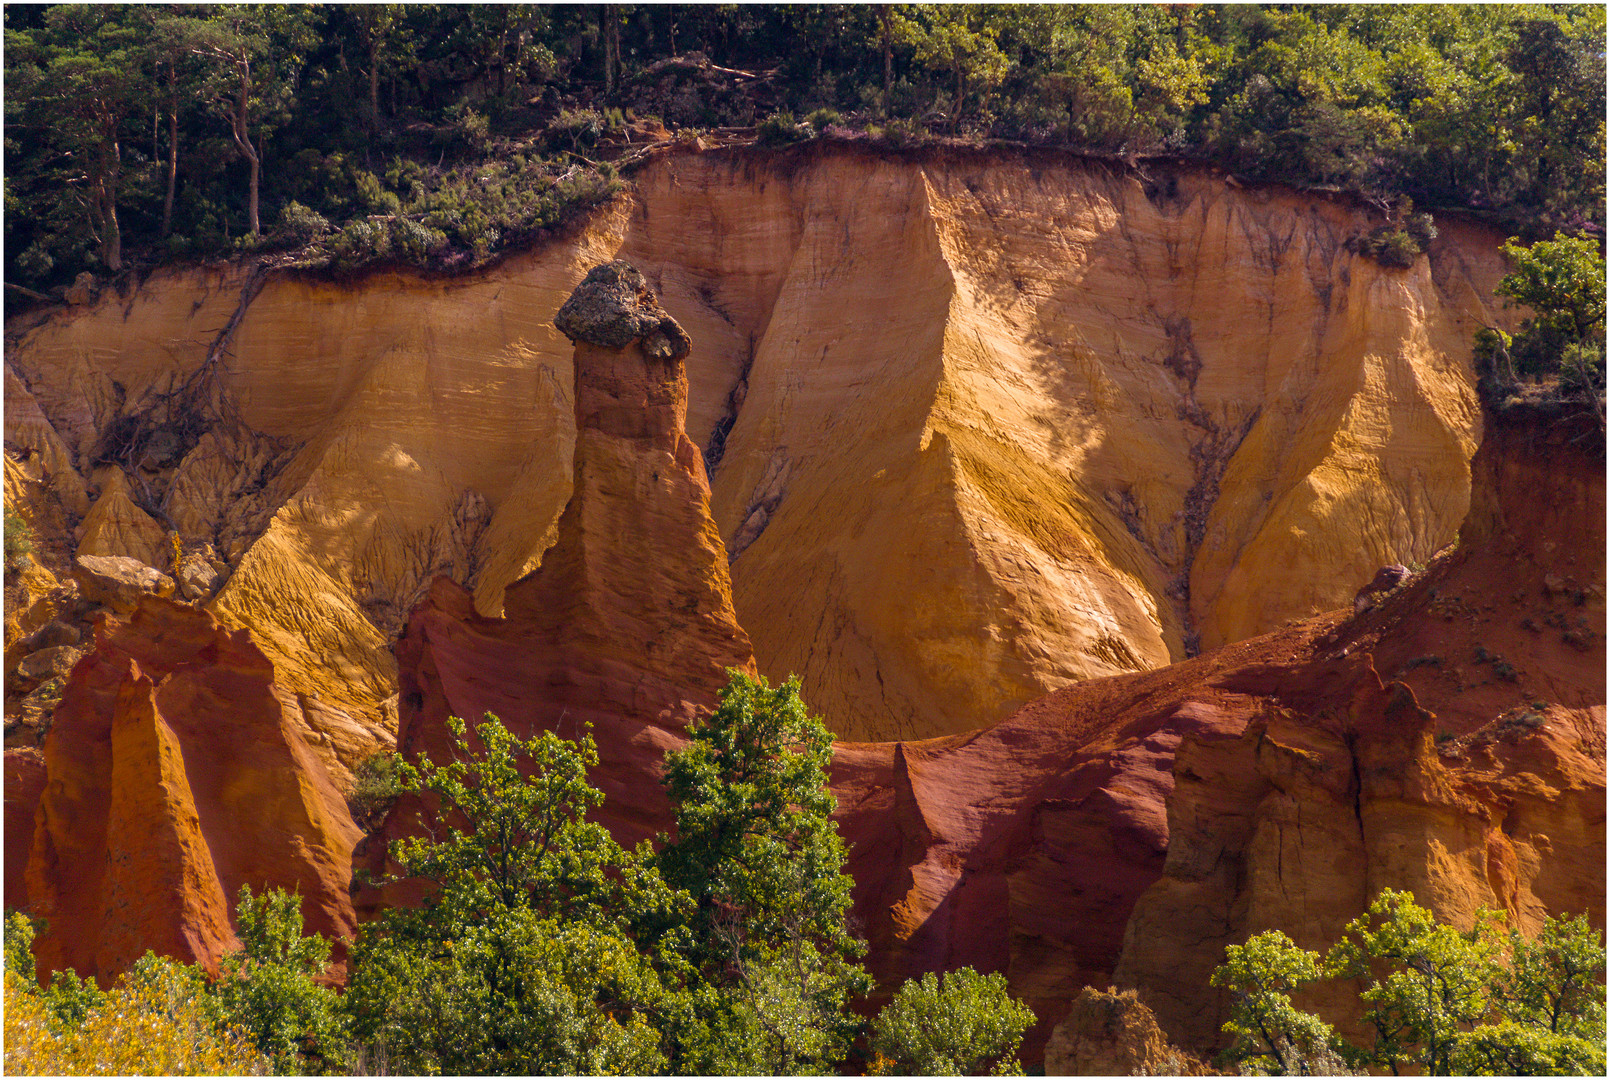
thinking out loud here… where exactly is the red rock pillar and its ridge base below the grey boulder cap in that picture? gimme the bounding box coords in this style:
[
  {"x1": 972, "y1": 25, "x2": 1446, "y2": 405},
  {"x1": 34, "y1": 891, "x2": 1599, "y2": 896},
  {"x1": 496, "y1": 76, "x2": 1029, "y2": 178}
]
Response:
[{"x1": 357, "y1": 264, "x2": 753, "y2": 909}]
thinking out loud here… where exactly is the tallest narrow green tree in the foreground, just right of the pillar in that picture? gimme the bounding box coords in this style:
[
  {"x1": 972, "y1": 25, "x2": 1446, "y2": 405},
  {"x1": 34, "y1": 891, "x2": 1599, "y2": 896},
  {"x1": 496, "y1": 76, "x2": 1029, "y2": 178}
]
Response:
[{"x1": 655, "y1": 670, "x2": 871, "y2": 1074}]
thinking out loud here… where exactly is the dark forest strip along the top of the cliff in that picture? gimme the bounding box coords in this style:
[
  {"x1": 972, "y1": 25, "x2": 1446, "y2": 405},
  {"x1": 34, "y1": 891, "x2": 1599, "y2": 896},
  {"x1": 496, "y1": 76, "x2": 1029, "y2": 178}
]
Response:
[{"x1": 5, "y1": 5, "x2": 1605, "y2": 304}]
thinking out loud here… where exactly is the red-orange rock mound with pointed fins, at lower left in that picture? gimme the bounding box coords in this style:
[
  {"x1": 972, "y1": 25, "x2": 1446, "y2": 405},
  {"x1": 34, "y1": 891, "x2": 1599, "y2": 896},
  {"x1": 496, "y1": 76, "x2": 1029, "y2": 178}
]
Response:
[{"x1": 22, "y1": 597, "x2": 359, "y2": 985}]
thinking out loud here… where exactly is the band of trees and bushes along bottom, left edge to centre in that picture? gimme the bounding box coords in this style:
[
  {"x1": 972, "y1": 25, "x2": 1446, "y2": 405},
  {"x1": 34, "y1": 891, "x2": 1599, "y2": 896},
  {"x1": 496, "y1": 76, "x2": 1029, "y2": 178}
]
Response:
[{"x1": 5, "y1": 671, "x2": 1034, "y2": 1075}]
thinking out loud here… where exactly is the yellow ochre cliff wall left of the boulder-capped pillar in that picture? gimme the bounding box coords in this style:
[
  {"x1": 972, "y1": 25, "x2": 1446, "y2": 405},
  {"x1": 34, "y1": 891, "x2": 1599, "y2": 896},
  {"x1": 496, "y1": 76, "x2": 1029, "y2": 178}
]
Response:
[{"x1": 6, "y1": 238, "x2": 624, "y2": 779}]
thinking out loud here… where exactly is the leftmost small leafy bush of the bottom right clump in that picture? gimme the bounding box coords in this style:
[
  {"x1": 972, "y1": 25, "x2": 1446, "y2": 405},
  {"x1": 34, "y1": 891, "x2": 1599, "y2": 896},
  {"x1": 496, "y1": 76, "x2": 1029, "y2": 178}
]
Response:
[{"x1": 1211, "y1": 930, "x2": 1343, "y2": 1075}]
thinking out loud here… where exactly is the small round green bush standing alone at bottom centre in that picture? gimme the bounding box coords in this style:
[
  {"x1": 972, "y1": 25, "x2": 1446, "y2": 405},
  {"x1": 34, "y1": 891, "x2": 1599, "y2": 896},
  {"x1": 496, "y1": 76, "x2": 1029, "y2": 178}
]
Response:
[{"x1": 873, "y1": 967, "x2": 1034, "y2": 1077}]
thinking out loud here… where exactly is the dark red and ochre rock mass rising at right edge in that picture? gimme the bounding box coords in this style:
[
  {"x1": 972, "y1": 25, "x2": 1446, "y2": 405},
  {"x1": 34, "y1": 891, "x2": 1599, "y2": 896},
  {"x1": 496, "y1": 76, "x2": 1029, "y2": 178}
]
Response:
[{"x1": 1114, "y1": 409, "x2": 1605, "y2": 1048}]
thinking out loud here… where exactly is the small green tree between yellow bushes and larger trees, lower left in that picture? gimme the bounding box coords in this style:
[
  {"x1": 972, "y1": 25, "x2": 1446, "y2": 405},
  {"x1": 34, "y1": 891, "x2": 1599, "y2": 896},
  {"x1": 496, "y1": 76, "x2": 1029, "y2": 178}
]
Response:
[{"x1": 213, "y1": 885, "x2": 346, "y2": 1075}]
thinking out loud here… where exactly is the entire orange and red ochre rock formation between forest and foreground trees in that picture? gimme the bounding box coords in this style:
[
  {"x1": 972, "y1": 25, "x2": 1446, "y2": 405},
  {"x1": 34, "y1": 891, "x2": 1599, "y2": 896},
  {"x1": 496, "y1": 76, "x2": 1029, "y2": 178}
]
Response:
[{"x1": 6, "y1": 155, "x2": 1605, "y2": 1064}]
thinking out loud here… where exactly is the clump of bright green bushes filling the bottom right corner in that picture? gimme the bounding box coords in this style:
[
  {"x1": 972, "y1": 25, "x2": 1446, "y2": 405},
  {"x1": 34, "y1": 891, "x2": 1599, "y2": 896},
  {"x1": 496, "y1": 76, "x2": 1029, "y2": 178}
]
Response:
[{"x1": 1212, "y1": 888, "x2": 1605, "y2": 1077}]
